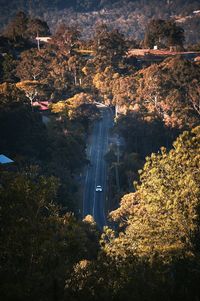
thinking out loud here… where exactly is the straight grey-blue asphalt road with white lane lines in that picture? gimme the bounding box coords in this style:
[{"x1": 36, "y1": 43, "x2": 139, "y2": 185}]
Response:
[{"x1": 83, "y1": 107, "x2": 113, "y2": 229}]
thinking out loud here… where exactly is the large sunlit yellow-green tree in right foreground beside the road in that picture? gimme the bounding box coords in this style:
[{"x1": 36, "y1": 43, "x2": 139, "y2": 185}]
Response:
[{"x1": 111, "y1": 127, "x2": 200, "y2": 260}]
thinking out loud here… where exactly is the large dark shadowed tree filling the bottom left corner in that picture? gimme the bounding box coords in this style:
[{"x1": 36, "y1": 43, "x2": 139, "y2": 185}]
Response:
[{"x1": 0, "y1": 167, "x2": 98, "y2": 301}]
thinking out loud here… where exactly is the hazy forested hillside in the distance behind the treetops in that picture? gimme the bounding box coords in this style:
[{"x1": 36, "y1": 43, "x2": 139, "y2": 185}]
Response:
[{"x1": 0, "y1": 0, "x2": 200, "y2": 43}]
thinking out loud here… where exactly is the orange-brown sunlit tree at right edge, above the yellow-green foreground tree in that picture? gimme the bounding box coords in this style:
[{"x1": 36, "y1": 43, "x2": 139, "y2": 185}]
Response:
[{"x1": 136, "y1": 57, "x2": 200, "y2": 128}]
